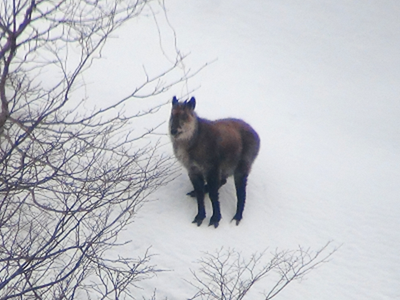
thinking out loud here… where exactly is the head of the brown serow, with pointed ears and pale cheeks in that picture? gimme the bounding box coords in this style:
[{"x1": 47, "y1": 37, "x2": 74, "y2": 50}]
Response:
[{"x1": 169, "y1": 96, "x2": 197, "y2": 140}]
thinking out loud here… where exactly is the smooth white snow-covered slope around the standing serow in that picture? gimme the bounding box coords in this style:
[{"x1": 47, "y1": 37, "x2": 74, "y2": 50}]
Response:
[{"x1": 87, "y1": 0, "x2": 400, "y2": 300}]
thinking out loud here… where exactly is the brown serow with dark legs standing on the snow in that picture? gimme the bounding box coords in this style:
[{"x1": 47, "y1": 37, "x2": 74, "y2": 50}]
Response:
[{"x1": 169, "y1": 97, "x2": 260, "y2": 228}]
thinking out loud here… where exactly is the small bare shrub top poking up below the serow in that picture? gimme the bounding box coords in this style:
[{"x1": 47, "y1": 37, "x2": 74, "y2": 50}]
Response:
[{"x1": 189, "y1": 243, "x2": 336, "y2": 300}]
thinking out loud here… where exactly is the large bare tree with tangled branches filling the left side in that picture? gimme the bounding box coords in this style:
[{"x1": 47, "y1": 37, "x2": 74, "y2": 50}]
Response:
[{"x1": 0, "y1": 0, "x2": 190, "y2": 299}]
